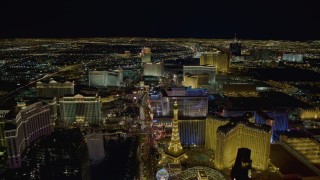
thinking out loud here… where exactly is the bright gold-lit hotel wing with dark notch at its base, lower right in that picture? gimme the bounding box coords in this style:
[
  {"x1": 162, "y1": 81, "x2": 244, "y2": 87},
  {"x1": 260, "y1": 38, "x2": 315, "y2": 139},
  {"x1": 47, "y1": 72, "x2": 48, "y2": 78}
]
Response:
[{"x1": 215, "y1": 115, "x2": 271, "y2": 170}]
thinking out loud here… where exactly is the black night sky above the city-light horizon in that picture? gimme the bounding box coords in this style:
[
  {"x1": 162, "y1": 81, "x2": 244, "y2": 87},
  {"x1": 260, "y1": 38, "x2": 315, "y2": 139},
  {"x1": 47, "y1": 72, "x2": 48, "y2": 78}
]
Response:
[{"x1": 0, "y1": 0, "x2": 320, "y2": 40}]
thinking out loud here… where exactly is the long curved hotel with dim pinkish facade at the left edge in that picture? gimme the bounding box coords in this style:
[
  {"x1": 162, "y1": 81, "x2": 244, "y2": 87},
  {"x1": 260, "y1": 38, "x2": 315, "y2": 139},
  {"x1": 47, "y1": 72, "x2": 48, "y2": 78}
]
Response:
[{"x1": 4, "y1": 101, "x2": 51, "y2": 168}]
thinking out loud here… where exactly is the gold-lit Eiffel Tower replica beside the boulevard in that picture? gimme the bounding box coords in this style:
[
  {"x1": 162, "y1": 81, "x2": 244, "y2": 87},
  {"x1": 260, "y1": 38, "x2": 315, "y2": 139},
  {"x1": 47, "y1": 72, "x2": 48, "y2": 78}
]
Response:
[{"x1": 159, "y1": 101, "x2": 187, "y2": 164}]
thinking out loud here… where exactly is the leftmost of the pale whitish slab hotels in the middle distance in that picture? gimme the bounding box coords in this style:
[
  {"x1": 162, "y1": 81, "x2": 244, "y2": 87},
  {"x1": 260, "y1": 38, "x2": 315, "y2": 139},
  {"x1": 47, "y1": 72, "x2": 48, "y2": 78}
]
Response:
[{"x1": 89, "y1": 69, "x2": 123, "y2": 87}]
